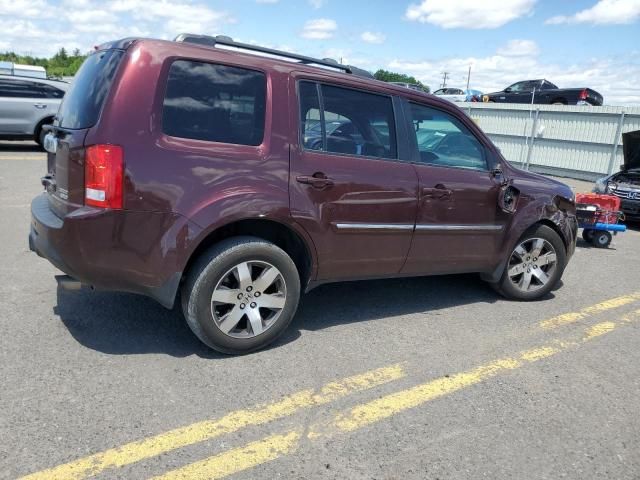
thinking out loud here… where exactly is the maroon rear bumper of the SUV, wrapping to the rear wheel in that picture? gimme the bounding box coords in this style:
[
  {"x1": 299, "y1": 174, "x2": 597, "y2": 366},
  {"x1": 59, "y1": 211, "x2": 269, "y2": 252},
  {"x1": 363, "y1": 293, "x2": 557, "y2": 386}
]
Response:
[{"x1": 29, "y1": 193, "x2": 196, "y2": 308}]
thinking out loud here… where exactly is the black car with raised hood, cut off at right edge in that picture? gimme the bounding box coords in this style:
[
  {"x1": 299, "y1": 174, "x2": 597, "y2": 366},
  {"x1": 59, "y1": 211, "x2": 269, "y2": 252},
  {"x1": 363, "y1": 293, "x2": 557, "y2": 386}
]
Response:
[{"x1": 594, "y1": 130, "x2": 640, "y2": 221}]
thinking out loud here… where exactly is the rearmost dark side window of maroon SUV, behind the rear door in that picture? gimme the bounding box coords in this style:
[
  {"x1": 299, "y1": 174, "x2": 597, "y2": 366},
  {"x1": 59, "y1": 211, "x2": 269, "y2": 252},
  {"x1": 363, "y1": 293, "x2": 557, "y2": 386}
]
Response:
[{"x1": 162, "y1": 60, "x2": 266, "y2": 145}]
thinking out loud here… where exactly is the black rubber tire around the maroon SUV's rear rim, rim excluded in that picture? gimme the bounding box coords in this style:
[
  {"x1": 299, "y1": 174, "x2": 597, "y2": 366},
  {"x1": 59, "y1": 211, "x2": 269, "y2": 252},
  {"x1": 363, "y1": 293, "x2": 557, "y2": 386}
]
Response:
[{"x1": 181, "y1": 236, "x2": 300, "y2": 354}]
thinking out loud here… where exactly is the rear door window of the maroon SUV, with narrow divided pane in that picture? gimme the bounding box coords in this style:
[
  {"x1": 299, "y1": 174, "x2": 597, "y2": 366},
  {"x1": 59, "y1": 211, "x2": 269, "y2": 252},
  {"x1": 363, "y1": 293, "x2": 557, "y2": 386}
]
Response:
[{"x1": 300, "y1": 82, "x2": 397, "y2": 158}]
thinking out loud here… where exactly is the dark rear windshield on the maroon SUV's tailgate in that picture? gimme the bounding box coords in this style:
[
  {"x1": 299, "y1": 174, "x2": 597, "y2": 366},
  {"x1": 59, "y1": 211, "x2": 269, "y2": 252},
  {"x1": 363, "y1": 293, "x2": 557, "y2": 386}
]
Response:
[{"x1": 58, "y1": 50, "x2": 124, "y2": 129}]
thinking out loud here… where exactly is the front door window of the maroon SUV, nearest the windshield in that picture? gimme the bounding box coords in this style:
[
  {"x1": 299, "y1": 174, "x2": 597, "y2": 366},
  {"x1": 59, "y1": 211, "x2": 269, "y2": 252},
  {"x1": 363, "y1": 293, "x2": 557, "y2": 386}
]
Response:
[{"x1": 411, "y1": 104, "x2": 487, "y2": 170}]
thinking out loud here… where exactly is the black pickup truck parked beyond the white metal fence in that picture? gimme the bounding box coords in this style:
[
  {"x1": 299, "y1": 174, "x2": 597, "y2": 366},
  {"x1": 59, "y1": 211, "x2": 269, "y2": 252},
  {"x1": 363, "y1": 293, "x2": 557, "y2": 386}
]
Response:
[{"x1": 482, "y1": 79, "x2": 603, "y2": 106}]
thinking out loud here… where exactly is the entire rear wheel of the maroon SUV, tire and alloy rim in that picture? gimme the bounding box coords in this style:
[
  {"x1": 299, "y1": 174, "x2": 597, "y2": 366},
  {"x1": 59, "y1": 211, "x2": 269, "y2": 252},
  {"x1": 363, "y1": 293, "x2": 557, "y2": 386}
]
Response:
[{"x1": 182, "y1": 237, "x2": 300, "y2": 354}]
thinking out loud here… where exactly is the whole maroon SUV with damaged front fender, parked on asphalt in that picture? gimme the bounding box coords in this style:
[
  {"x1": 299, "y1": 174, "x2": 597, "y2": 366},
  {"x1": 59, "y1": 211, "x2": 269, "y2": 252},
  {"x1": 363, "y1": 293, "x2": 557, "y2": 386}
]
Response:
[{"x1": 29, "y1": 35, "x2": 577, "y2": 353}]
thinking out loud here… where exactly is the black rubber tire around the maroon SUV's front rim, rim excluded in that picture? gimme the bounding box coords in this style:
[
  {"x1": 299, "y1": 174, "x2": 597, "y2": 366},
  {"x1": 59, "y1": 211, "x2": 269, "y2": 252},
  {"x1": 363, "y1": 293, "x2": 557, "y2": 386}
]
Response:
[{"x1": 494, "y1": 225, "x2": 567, "y2": 301}]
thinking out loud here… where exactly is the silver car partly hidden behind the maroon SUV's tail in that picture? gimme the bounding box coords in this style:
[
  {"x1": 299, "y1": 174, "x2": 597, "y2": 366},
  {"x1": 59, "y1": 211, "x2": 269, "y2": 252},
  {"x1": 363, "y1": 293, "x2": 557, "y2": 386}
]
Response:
[{"x1": 0, "y1": 75, "x2": 69, "y2": 145}]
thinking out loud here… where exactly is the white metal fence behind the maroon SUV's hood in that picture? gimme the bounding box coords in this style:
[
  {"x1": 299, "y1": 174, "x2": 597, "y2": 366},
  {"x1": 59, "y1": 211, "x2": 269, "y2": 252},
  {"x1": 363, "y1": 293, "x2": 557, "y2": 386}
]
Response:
[{"x1": 458, "y1": 103, "x2": 640, "y2": 180}]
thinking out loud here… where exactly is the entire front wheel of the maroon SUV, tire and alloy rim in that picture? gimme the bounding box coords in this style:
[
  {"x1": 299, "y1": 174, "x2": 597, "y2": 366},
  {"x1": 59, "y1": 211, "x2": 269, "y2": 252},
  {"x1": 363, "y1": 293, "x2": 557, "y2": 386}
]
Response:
[{"x1": 498, "y1": 225, "x2": 566, "y2": 300}]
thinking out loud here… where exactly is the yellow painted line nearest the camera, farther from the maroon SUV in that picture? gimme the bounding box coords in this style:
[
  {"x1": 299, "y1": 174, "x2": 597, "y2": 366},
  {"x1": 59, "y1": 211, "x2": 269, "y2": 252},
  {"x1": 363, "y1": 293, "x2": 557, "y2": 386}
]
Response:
[{"x1": 152, "y1": 316, "x2": 640, "y2": 480}]
